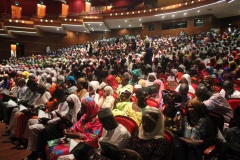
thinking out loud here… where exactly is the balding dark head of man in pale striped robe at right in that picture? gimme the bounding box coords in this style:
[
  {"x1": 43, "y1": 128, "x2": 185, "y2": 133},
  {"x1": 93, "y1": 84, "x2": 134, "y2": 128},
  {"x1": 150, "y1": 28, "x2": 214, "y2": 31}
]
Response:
[{"x1": 196, "y1": 83, "x2": 213, "y2": 101}]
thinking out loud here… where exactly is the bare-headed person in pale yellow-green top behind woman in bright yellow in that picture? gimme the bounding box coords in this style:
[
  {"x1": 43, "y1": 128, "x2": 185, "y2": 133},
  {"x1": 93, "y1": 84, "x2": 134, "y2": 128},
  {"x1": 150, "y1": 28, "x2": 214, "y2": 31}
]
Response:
[{"x1": 116, "y1": 72, "x2": 133, "y2": 97}]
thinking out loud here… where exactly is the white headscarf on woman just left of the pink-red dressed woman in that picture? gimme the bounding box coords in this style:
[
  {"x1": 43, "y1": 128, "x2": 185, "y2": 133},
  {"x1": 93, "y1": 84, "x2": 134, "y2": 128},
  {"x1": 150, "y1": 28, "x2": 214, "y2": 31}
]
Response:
[{"x1": 67, "y1": 94, "x2": 81, "y2": 123}]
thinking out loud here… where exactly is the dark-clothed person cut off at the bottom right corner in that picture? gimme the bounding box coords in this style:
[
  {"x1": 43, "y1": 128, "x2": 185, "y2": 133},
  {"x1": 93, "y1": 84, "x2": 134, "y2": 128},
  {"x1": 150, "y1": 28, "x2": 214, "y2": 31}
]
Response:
[{"x1": 218, "y1": 106, "x2": 240, "y2": 160}]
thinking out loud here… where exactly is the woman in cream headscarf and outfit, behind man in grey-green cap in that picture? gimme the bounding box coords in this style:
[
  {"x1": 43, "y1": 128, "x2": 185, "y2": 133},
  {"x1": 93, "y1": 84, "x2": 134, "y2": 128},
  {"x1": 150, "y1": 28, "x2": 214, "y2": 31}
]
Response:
[{"x1": 98, "y1": 86, "x2": 115, "y2": 109}]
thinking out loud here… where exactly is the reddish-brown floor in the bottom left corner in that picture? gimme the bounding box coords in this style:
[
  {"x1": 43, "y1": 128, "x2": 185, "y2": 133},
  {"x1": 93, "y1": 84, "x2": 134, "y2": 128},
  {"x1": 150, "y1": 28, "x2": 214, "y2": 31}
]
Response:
[{"x1": 0, "y1": 123, "x2": 31, "y2": 160}]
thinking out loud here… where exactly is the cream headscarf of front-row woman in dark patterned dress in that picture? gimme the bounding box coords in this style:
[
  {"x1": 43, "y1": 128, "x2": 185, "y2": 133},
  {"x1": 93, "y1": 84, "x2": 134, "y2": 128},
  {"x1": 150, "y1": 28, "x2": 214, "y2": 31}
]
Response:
[{"x1": 138, "y1": 107, "x2": 164, "y2": 140}]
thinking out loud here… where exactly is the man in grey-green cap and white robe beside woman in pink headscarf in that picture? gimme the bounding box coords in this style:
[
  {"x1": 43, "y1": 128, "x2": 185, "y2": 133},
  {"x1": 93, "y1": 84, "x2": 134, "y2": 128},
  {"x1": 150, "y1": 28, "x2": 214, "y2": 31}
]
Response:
[{"x1": 58, "y1": 108, "x2": 131, "y2": 160}]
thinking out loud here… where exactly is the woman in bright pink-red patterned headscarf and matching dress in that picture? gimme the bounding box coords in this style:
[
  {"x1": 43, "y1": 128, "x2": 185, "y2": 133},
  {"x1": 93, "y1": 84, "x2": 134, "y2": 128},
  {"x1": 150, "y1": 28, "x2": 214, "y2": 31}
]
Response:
[{"x1": 37, "y1": 97, "x2": 102, "y2": 159}]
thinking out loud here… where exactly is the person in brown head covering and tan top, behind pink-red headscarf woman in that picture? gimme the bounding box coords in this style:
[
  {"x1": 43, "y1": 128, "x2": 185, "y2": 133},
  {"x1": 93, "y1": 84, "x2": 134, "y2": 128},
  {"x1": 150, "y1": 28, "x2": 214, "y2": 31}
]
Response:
[{"x1": 74, "y1": 78, "x2": 89, "y2": 101}]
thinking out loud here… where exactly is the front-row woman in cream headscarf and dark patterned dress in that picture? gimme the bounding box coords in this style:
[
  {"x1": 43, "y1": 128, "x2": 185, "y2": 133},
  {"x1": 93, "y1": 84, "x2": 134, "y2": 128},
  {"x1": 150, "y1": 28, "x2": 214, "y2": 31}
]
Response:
[{"x1": 122, "y1": 107, "x2": 167, "y2": 160}]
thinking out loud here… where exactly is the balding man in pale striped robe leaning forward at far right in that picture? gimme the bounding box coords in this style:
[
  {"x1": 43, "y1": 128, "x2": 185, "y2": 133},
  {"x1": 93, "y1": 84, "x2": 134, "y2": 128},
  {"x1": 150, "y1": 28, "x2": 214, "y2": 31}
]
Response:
[{"x1": 196, "y1": 84, "x2": 233, "y2": 123}]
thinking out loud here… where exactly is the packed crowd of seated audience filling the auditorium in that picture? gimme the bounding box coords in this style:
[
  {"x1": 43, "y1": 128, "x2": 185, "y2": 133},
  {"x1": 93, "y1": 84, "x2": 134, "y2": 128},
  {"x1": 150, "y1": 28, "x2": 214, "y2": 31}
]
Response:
[{"x1": 0, "y1": 29, "x2": 240, "y2": 160}]
